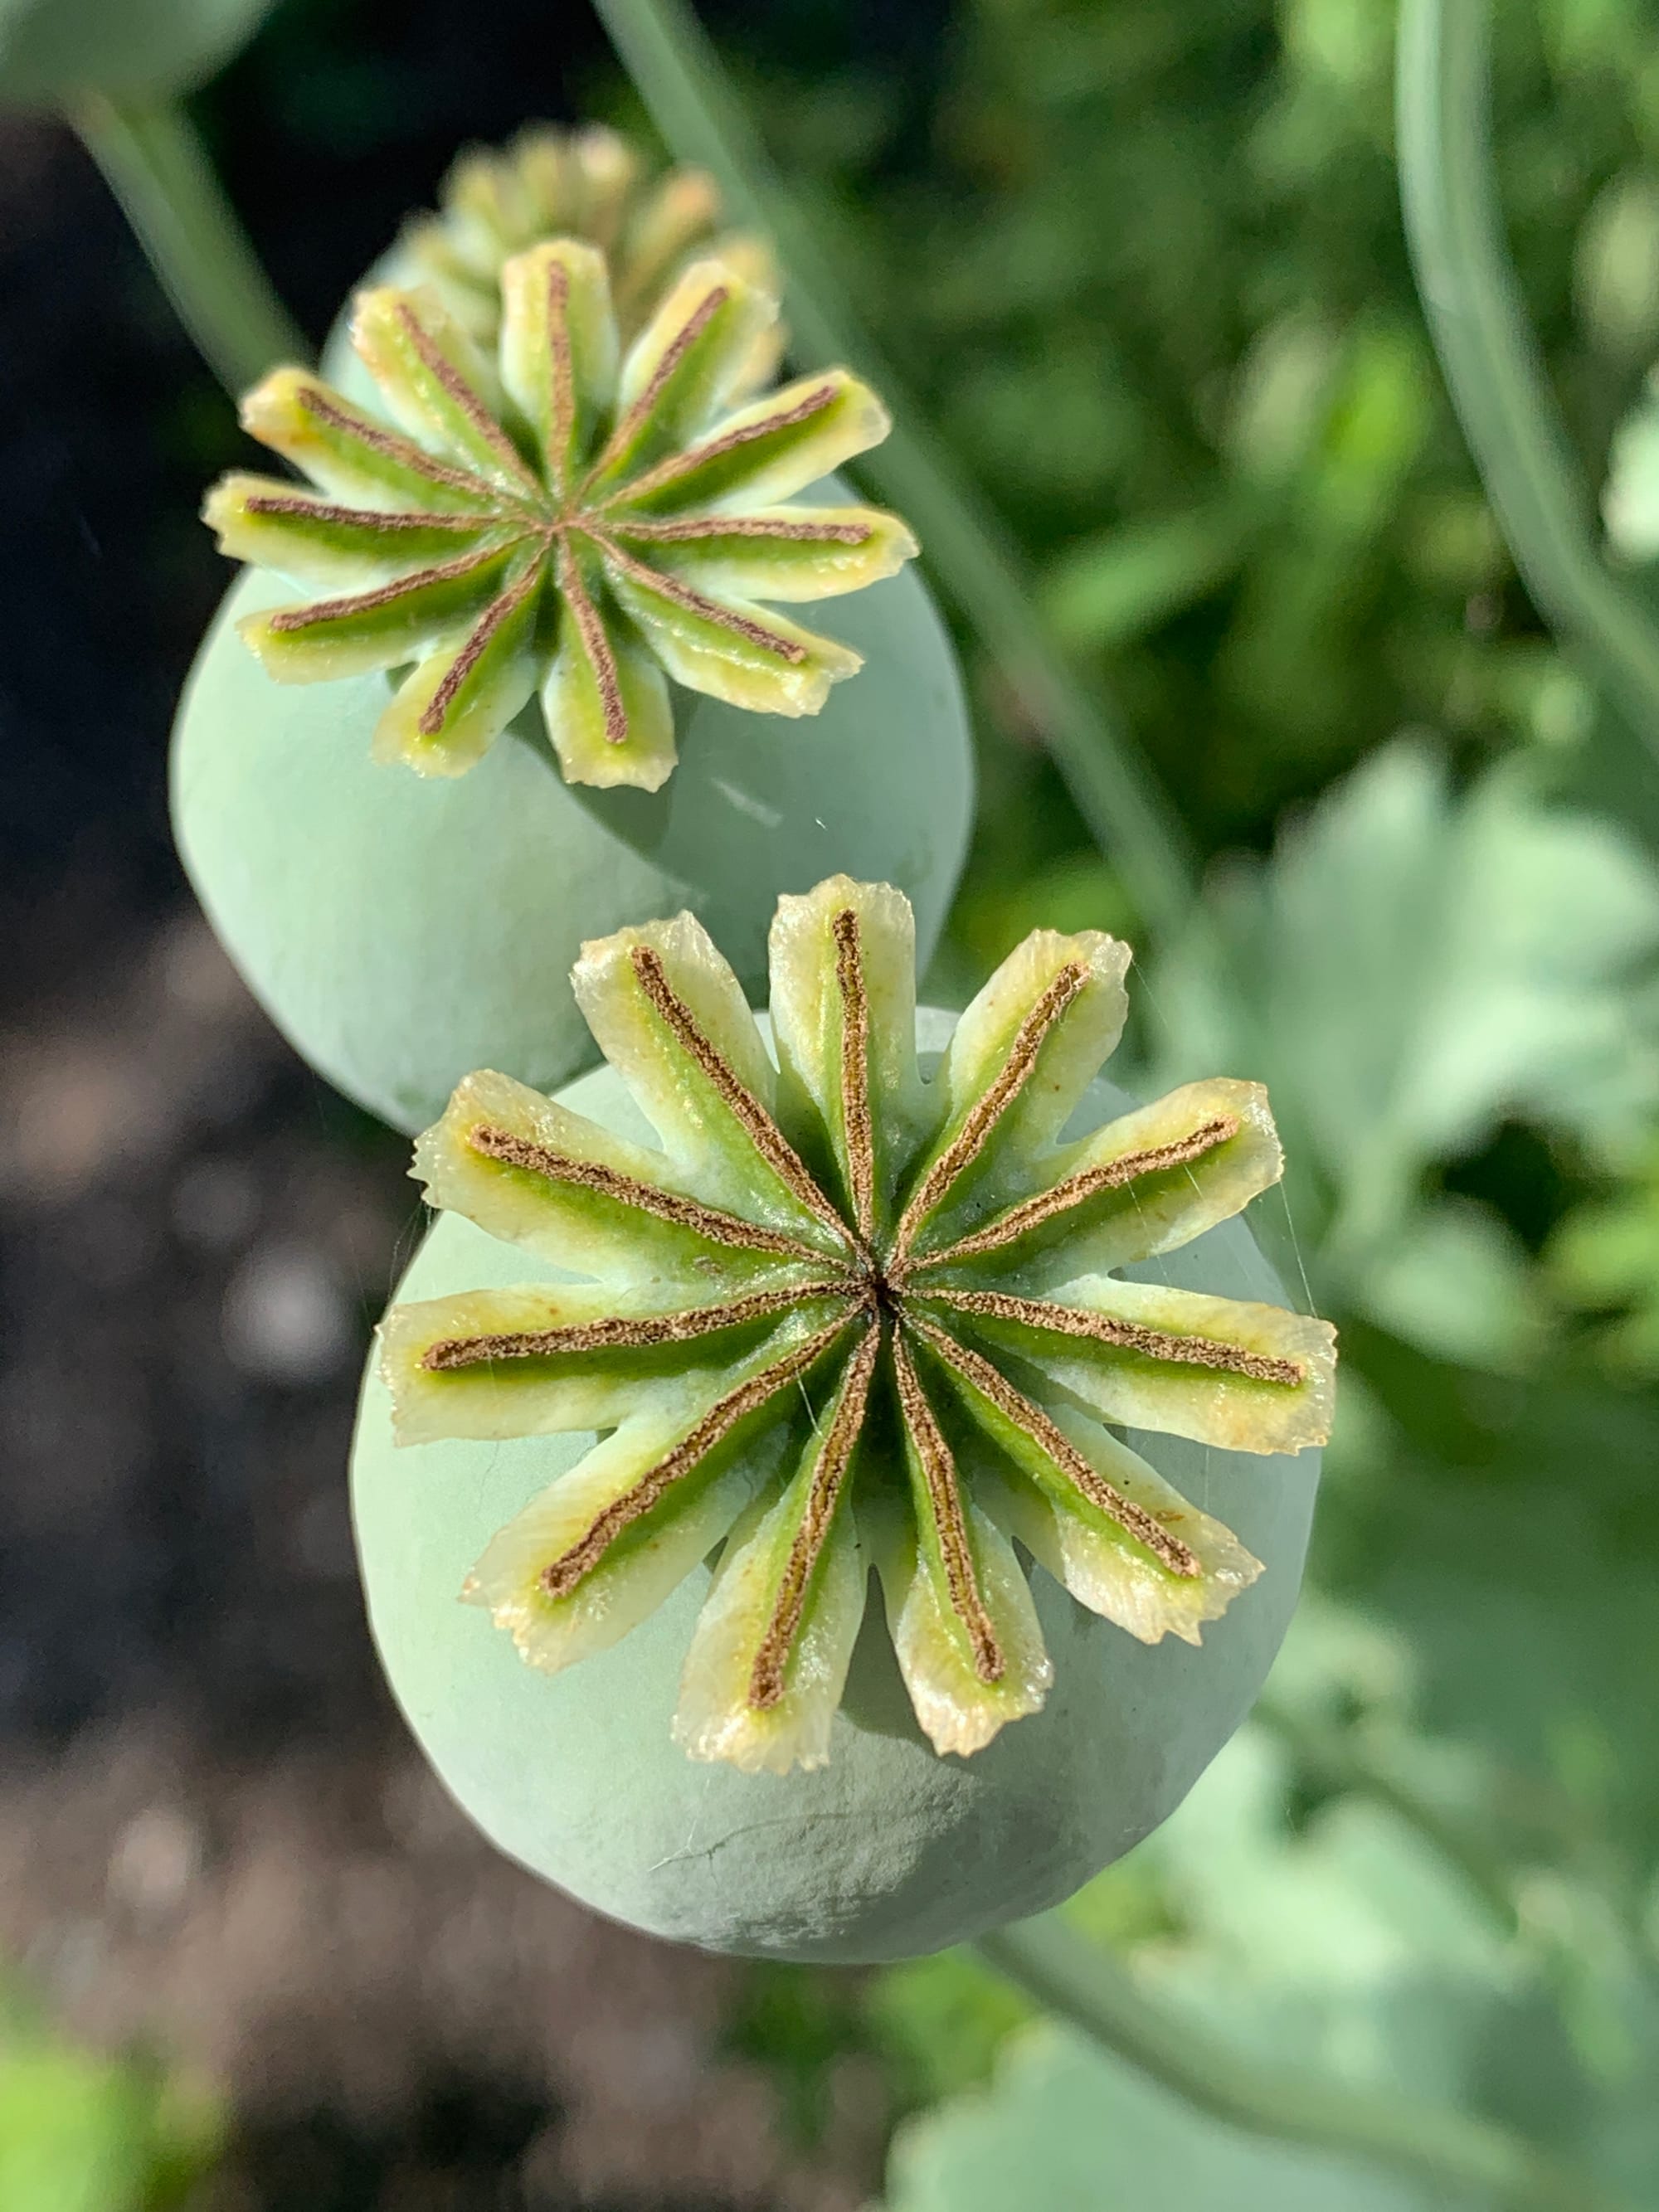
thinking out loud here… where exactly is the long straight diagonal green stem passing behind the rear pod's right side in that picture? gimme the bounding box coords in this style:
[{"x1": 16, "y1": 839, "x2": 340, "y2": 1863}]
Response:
[{"x1": 595, "y1": 0, "x2": 1197, "y2": 938}]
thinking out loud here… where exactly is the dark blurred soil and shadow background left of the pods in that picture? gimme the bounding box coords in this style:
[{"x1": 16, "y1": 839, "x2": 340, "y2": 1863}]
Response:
[{"x1": 0, "y1": 0, "x2": 932, "y2": 2212}]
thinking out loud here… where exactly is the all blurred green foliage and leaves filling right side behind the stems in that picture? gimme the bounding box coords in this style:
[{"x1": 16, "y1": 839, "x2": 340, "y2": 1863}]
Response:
[{"x1": 690, "y1": 0, "x2": 1659, "y2": 2212}]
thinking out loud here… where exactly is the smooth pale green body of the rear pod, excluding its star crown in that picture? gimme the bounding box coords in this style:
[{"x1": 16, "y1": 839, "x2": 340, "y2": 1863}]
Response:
[{"x1": 173, "y1": 552, "x2": 973, "y2": 1130}]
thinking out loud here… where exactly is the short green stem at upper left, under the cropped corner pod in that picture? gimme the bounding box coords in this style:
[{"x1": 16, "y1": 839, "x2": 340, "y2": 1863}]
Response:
[{"x1": 71, "y1": 93, "x2": 309, "y2": 401}]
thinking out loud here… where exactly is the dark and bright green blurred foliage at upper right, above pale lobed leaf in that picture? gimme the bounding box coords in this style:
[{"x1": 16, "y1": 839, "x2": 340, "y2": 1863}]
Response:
[{"x1": 721, "y1": 0, "x2": 1659, "y2": 863}]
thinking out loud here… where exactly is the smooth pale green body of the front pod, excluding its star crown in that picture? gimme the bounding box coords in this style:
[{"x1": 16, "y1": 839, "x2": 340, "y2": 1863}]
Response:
[{"x1": 352, "y1": 1043, "x2": 1318, "y2": 1962}]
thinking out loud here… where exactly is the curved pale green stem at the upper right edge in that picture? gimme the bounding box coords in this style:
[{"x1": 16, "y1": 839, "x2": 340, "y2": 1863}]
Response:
[{"x1": 1396, "y1": 0, "x2": 1659, "y2": 756}]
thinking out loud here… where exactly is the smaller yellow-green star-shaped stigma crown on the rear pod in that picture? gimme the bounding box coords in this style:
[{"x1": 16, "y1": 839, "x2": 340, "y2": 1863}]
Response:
[{"x1": 206, "y1": 239, "x2": 916, "y2": 790}]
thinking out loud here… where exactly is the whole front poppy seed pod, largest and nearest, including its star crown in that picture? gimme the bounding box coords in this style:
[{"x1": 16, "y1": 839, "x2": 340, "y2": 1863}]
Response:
[{"x1": 354, "y1": 878, "x2": 1331, "y2": 1960}]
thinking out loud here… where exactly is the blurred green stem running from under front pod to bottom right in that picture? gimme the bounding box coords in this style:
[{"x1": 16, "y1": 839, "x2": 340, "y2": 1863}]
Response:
[{"x1": 975, "y1": 1916, "x2": 1628, "y2": 2212}]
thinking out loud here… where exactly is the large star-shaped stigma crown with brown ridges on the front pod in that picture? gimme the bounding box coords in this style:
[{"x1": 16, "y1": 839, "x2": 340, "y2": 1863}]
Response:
[{"x1": 382, "y1": 878, "x2": 1334, "y2": 1772}]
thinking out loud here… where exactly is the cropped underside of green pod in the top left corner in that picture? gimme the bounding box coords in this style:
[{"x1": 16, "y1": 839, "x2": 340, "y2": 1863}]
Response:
[{"x1": 0, "y1": 0, "x2": 272, "y2": 106}]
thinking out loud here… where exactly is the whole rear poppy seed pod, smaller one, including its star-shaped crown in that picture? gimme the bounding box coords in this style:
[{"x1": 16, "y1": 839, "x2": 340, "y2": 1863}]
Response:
[{"x1": 173, "y1": 229, "x2": 973, "y2": 1130}]
